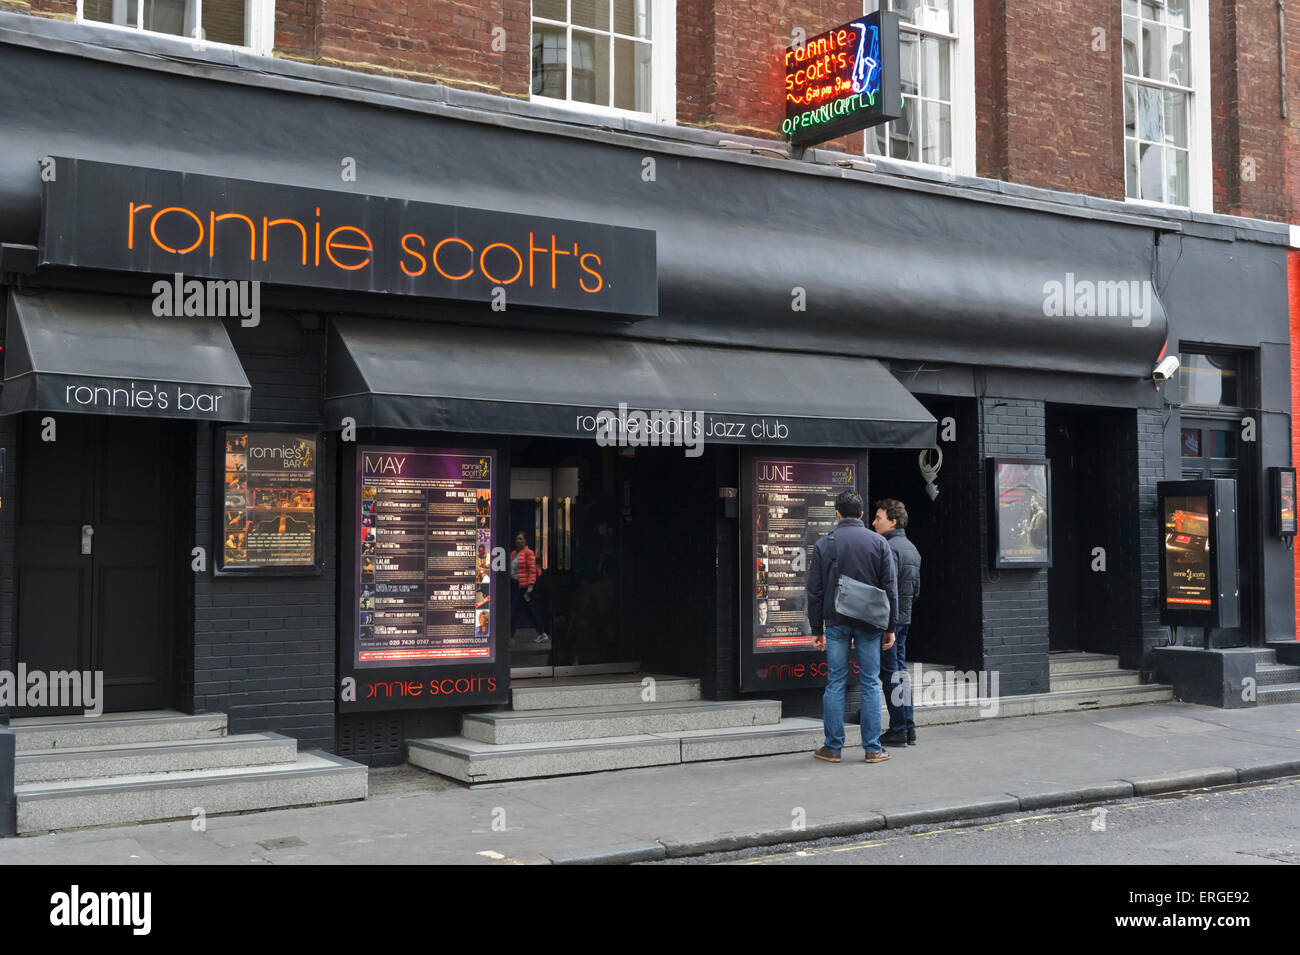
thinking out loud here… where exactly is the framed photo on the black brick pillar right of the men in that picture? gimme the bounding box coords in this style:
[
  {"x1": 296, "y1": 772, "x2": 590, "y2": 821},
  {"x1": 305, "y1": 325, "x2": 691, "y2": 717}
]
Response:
[{"x1": 988, "y1": 457, "x2": 1052, "y2": 569}]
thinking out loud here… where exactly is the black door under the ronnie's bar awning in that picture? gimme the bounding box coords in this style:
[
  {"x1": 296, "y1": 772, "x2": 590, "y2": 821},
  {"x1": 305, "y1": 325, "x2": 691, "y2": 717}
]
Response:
[{"x1": 16, "y1": 414, "x2": 180, "y2": 716}]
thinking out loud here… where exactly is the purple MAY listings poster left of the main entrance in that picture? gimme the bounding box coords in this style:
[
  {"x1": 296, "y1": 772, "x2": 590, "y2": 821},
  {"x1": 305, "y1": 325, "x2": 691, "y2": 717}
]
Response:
[{"x1": 354, "y1": 447, "x2": 497, "y2": 667}]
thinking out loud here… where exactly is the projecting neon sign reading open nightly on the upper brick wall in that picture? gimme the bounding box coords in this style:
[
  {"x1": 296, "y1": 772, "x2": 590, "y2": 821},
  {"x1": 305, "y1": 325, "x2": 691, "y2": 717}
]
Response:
[{"x1": 781, "y1": 13, "x2": 902, "y2": 144}]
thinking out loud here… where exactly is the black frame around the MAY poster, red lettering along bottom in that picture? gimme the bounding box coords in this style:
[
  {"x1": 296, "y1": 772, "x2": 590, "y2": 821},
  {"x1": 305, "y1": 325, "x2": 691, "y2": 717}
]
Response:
[{"x1": 335, "y1": 429, "x2": 510, "y2": 713}]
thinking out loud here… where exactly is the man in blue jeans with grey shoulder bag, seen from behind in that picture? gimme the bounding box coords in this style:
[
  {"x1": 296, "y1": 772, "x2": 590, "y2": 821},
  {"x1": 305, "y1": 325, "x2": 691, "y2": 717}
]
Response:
[{"x1": 806, "y1": 491, "x2": 898, "y2": 763}]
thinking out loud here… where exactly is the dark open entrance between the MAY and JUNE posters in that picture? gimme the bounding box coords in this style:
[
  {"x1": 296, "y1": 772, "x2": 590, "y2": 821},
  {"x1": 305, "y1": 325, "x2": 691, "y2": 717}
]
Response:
[{"x1": 508, "y1": 438, "x2": 718, "y2": 677}]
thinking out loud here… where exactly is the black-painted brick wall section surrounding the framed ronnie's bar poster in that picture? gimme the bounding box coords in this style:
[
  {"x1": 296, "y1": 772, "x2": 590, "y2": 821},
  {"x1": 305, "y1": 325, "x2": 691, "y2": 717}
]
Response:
[{"x1": 192, "y1": 314, "x2": 338, "y2": 750}]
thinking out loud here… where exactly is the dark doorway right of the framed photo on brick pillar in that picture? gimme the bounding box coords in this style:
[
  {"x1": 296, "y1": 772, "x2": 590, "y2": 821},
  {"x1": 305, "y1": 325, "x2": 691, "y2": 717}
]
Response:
[{"x1": 1045, "y1": 404, "x2": 1141, "y2": 654}]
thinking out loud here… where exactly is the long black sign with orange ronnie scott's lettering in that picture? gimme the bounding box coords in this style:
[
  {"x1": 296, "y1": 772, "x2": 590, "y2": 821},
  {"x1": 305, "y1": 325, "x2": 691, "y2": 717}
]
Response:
[{"x1": 40, "y1": 157, "x2": 659, "y2": 316}]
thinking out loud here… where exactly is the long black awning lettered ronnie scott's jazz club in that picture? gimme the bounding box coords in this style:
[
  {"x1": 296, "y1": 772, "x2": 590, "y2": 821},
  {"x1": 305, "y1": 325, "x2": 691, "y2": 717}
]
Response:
[{"x1": 325, "y1": 318, "x2": 935, "y2": 448}]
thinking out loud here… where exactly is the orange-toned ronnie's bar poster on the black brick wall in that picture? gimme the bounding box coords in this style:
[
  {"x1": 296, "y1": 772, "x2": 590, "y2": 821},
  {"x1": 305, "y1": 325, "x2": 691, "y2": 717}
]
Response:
[{"x1": 217, "y1": 427, "x2": 317, "y2": 573}]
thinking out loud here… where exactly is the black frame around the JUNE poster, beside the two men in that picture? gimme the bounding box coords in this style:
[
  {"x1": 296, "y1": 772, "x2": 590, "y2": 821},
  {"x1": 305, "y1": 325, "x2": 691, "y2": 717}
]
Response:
[{"x1": 736, "y1": 446, "x2": 871, "y2": 693}]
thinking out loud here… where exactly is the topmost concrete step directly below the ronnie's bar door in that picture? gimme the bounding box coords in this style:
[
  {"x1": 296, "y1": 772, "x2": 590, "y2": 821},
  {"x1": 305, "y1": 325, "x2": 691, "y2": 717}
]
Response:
[{"x1": 10, "y1": 709, "x2": 226, "y2": 752}]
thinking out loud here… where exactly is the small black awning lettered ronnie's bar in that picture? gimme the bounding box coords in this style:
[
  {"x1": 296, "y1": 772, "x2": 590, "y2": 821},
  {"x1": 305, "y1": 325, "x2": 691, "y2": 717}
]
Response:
[{"x1": 0, "y1": 292, "x2": 251, "y2": 421}]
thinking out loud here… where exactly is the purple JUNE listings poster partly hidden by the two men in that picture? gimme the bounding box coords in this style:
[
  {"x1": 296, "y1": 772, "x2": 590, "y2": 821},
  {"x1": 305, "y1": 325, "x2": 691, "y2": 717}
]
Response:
[{"x1": 750, "y1": 457, "x2": 858, "y2": 654}]
